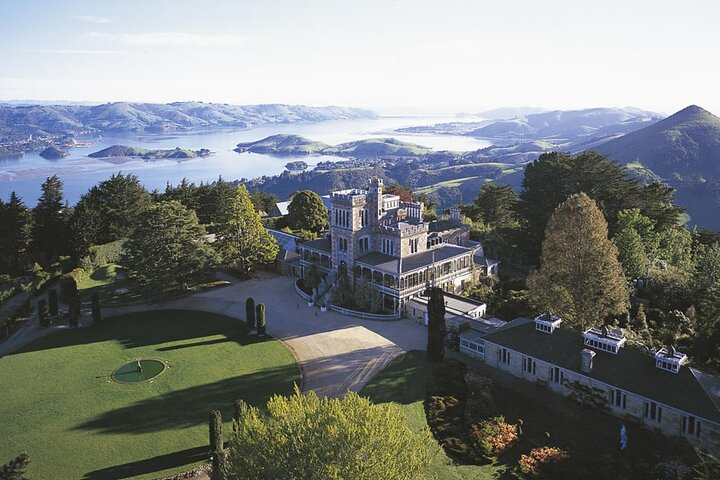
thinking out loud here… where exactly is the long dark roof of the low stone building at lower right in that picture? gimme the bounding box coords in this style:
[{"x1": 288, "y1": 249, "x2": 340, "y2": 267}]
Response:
[{"x1": 485, "y1": 319, "x2": 720, "y2": 423}]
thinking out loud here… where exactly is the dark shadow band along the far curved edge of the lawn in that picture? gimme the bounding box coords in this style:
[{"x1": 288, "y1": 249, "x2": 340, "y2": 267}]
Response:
[{"x1": 11, "y1": 310, "x2": 253, "y2": 355}]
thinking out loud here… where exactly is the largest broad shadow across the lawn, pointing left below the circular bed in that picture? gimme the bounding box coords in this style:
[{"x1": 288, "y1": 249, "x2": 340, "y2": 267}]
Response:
[{"x1": 74, "y1": 364, "x2": 299, "y2": 434}]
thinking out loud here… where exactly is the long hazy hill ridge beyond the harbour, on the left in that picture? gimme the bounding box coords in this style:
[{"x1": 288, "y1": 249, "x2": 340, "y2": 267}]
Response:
[{"x1": 0, "y1": 102, "x2": 374, "y2": 141}]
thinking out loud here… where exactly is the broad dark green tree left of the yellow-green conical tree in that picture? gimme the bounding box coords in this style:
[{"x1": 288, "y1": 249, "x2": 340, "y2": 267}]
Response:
[{"x1": 121, "y1": 200, "x2": 215, "y2": 292}]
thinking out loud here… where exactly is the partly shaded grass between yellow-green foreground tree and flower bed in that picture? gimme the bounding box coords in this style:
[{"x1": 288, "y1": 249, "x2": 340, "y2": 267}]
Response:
[{"x1": 360, "y1": 351, "x2": 506, "y2": 480}]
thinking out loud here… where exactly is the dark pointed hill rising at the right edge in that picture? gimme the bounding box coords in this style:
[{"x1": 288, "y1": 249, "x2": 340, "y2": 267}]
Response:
[{"x1": 595, "y1": 105, "x2": 720, "y2": 229}]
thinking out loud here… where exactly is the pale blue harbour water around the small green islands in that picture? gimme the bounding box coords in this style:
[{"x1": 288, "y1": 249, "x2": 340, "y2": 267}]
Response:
[{"x1": 0, "y1": 116, "x2": 490, "y2": 205}]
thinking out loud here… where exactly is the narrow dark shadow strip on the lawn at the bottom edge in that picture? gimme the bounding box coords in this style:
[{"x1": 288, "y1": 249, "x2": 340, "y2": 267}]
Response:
[{"x1": 83, "y1": 445, "x2": 208, "y2": 480}]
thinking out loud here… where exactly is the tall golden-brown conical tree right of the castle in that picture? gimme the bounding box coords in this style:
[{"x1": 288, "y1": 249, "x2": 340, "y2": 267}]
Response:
[{"x1": 528, "y1": 193, "x2": 629, "y2": 330}]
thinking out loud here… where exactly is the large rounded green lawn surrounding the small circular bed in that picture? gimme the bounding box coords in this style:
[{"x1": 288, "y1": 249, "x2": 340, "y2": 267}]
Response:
[{"x1": 0, "y1": 311, "x2": 299, "y2": 480}]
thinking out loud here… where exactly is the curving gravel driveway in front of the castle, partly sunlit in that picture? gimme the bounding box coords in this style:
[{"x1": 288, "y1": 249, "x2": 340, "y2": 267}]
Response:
[{"x1": 103, "y1": 272, "x2": 427, "y2": 397}]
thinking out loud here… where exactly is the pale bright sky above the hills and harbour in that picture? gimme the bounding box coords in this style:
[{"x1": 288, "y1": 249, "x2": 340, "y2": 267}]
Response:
[{"x1": 0, "y1": 0, "x2": 720, "y2": 114}]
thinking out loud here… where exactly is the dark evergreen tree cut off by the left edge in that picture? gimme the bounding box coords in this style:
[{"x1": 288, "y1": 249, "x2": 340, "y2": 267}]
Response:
[{"x1": 0, "y1": 192, "x2": 32, "y2": 275}]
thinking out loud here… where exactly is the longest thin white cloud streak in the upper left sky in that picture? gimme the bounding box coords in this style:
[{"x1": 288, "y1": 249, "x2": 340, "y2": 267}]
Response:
[{"x1": 83, "y1": 32, "x2": 246, "y2": 47}]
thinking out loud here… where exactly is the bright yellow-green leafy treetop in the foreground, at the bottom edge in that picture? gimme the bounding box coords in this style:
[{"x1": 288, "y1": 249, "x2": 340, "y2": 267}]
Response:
[{"x1": 227, "y1": 388, "x2": 431, "y2": 480}]
